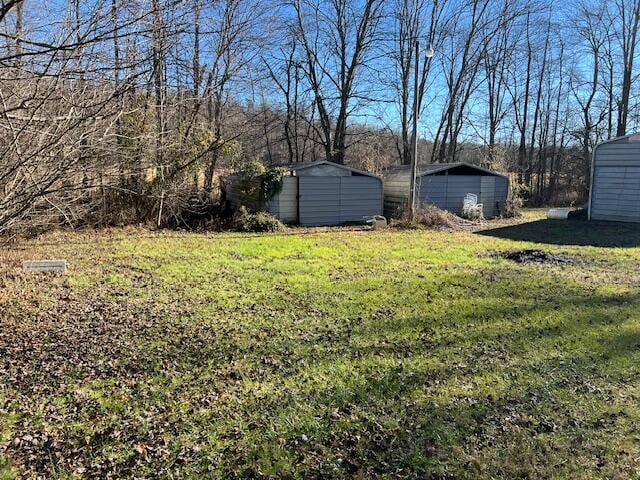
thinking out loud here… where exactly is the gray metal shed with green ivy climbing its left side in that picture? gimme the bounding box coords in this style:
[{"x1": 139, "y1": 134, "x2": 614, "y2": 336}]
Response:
[{"x1": 225, "y1": 161, "x2": 383, "y2": 226}]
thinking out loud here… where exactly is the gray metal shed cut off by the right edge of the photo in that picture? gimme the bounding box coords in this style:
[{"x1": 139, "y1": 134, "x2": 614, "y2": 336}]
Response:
[{"x1": 589, "y1": 134, "x2": 640, "y2": 222}]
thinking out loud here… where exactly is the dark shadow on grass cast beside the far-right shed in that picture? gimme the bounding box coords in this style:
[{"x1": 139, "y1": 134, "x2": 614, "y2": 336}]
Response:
[{"x1": 476, "y1": 220, "x2": 640, "y2": 248}]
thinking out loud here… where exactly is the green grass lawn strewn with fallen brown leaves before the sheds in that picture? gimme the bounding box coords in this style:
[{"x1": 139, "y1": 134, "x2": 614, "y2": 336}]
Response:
[{"x1": 0, "y1": 212, "x2": 640, "y2": 479}]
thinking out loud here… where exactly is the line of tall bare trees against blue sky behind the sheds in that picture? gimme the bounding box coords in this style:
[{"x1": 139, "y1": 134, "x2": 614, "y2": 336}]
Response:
[{"x1": 0, "y1": 0, "x2": 640, "y2": 233}]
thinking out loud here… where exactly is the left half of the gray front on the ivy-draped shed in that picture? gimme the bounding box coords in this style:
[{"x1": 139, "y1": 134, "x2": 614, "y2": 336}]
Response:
[{"x1": 298, "y1": 176, "x2": 341, "y2": 226}]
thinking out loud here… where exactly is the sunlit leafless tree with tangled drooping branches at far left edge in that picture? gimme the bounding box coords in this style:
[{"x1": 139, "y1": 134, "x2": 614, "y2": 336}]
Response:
[{"x1": 0, "y1": 2, "x2": 131, "y2": 232}]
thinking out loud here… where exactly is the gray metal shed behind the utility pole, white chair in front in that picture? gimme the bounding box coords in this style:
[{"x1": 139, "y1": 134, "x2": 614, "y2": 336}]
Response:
[{"x1": 384, "y1": 162, "x2": 509, "y2": 218}]
